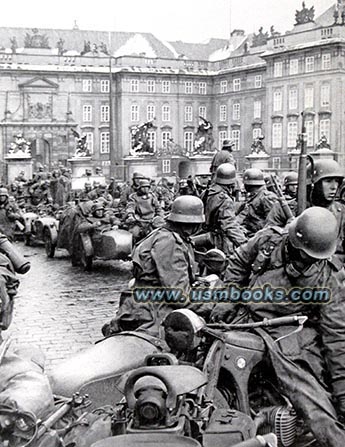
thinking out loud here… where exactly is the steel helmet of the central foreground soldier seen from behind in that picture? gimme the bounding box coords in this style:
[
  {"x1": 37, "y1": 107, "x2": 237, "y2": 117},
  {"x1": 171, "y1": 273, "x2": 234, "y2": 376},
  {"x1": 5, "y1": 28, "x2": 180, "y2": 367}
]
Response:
[{"x1": 167, "y1": 195, "x2": 205, "y2": 223}]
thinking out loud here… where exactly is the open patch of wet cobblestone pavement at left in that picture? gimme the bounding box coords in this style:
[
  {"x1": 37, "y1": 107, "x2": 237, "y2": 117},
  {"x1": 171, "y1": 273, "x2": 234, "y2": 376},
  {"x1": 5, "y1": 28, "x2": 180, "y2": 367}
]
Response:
[{"x1": 3, "y1": 243, "x2": 131, "y2": 370}]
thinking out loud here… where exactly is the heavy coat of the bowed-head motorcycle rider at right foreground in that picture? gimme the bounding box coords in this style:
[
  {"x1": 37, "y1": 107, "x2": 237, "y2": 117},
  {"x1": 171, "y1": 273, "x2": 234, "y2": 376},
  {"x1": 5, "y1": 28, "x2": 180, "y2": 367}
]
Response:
[{"x1": 213, "y1": 227, "x2": 345, "y2": 447}]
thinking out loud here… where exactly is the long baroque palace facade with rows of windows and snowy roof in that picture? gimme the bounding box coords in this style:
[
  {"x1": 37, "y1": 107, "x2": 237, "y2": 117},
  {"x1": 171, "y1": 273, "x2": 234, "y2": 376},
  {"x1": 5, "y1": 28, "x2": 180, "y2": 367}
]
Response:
[{"x1": 0, "y1": 0, "x2": 345, "y2": 178}]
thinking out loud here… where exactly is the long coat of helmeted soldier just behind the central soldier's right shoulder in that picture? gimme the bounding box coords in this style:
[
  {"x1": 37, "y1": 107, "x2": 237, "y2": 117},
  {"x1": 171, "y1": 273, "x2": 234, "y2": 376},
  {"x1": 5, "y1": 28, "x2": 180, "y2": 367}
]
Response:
[{"x1": 205, "y1": 184, "x2": 247, "y2": 255}]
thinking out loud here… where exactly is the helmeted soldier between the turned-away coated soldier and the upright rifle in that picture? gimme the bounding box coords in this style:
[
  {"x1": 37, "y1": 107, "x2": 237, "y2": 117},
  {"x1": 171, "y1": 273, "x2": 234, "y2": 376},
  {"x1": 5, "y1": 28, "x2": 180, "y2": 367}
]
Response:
[{"x1": 237, "y1": 168, "x2": 278, "y2": 236}]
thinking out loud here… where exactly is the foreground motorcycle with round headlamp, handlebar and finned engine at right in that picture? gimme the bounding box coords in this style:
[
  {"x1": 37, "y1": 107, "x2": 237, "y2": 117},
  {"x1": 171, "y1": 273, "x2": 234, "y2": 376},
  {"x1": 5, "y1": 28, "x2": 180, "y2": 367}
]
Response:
[{"x1": 164, "y1": 309, "x2": 314, "y2": 447}]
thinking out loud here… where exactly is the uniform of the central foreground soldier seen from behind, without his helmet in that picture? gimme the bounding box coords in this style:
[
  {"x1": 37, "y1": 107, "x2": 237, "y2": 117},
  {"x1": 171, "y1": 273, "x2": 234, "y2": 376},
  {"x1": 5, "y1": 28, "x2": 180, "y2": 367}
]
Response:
[{"x1": 111, "y1": 225, "x2": 197, "y2": 336}]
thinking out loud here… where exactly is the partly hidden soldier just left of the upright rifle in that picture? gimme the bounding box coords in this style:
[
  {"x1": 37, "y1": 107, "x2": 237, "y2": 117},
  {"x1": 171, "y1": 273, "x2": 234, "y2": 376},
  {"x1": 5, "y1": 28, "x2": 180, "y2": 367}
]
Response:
[{"x1": 266, "y1": 171, "x2": 298, "y2": 227}]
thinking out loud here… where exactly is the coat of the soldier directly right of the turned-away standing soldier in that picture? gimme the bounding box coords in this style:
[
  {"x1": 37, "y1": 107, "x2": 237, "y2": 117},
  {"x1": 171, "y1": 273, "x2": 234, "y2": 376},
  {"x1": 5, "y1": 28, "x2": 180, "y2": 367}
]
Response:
[{"x1": 237, "y1": 186, "x2": 278, "y2": 236}]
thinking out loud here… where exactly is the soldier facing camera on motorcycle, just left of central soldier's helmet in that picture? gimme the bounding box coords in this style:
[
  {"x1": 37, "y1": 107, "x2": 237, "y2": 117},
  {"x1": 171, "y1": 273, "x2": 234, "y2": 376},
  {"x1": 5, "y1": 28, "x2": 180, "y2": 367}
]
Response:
[{"x1": 126, "y1": 180, "x2": 164, "y2": 240}]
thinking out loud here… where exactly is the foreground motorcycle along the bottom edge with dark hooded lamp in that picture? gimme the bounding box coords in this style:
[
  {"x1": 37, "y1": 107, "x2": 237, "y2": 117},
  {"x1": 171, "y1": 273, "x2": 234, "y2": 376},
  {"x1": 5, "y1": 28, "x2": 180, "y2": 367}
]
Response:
[{"x1": 0, "y1": 346, "x2": 277, "y2": 447}]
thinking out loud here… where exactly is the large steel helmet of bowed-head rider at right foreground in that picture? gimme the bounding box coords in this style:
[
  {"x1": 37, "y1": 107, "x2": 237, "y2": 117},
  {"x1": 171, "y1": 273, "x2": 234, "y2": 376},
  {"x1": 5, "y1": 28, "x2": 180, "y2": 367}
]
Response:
[{"x1": 289, "y1": 206, "x2": 338, "y2": 259}]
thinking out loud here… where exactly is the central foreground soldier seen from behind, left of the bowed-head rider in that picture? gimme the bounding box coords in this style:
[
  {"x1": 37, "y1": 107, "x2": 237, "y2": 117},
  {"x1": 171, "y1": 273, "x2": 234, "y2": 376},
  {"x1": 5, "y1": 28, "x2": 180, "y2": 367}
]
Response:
[{"x1": 102, "y1": 196, "x2": 210, "y2": 337}]
